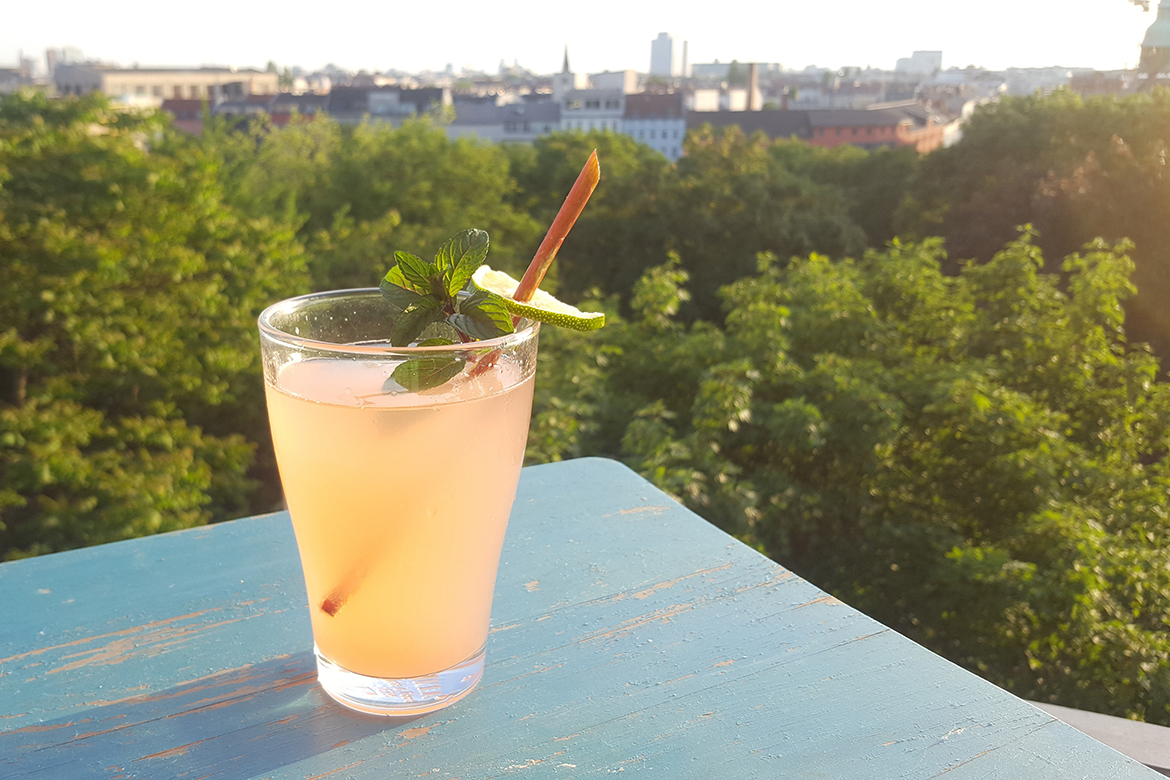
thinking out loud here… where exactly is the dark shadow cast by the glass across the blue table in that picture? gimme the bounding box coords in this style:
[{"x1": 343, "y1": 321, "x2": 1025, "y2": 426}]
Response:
[{"x1": 0, "y1": 653, "x2": 421, "y2": 780}]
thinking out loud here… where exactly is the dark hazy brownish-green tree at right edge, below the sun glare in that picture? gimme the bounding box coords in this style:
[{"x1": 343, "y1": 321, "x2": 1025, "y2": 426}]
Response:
[{"x1": 899, "y1": 90, "x2": 1170, "y2": 360}]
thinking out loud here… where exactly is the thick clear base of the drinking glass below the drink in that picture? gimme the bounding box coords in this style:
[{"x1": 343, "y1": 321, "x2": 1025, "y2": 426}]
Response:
[{"x1": 312, "y1": 644, "x2": 483, "y2": 717}]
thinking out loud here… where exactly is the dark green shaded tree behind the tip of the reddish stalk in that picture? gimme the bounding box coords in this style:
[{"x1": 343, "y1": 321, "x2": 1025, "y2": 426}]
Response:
[{"x1": 514, "y1": 127, "x2": 865, "y2": 320}]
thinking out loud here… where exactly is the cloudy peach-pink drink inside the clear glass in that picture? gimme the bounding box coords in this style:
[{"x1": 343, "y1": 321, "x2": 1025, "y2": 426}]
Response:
[{"x1": 267, "y1": 360, "x2": 532, "y2": 677}]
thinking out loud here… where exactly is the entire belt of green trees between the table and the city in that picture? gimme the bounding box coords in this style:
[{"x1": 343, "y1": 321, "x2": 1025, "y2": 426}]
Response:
[{"x1": 0, "y1": 94, "x2": 1170, "y2": 724}]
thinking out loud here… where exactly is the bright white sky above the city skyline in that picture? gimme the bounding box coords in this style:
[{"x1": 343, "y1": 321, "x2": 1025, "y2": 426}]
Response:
[{"x1": 0, "y1": 0, "x2": 1157, "y2": 73}]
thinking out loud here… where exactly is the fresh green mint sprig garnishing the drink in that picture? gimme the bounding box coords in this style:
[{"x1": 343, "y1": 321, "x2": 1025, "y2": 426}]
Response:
[{"x1": 379, "y1": 229, "x2": 516, "y2": 392}]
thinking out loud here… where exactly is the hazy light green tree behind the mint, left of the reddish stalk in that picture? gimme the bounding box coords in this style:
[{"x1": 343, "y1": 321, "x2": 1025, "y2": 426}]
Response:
[{"x1": 205, "y1": 115, "x2": 539, "y2": 289}]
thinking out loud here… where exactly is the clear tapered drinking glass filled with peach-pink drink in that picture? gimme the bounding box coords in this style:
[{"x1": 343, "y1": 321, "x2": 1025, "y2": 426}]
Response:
[{"x1": 260, "y1": 289, "x2": 538, "y2": 716}]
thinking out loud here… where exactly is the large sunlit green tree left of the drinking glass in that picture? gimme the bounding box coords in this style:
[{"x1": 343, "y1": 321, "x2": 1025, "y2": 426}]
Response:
[{"x1": 0, "y1": 92, "x2": 305, "y2": 558}]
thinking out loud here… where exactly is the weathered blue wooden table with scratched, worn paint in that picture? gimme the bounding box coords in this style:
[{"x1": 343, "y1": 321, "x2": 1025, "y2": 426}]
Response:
[{"x1": 0, "y1": 460, "x2": 1161, "y2": 780}]
